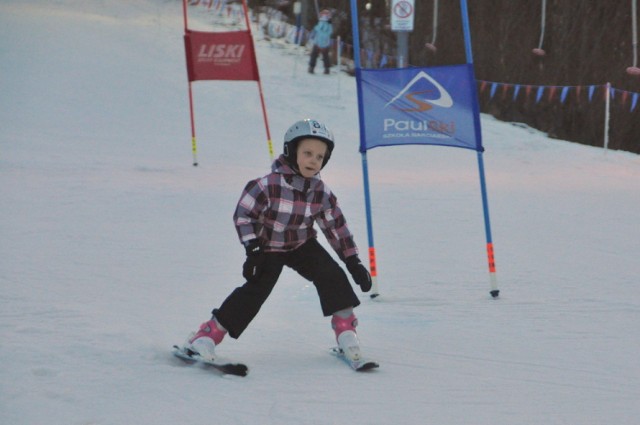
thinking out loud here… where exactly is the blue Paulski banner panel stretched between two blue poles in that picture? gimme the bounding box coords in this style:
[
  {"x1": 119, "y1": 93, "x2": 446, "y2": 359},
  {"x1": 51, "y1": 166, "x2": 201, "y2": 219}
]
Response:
[{"x1": 356, "y1": 64, "x2": 483, "y2": 152}]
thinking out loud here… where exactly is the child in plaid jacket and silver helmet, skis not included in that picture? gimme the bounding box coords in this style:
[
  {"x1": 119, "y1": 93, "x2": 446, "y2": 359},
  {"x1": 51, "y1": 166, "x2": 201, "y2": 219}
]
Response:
[{"x1": 183, "y1": 119, "x2": 371, "y2": 361}]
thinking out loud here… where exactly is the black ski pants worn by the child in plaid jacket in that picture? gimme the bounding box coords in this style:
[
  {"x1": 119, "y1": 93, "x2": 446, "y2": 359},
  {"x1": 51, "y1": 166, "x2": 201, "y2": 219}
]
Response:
[{"x1": 213, "y1": 238, "x2": 360, "y2": 338}]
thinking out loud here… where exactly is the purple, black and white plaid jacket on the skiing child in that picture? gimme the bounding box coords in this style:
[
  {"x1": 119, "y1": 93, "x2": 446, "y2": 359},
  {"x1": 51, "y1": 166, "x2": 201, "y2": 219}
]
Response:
[{"x1": 233, "y1": 156, "x2": 358, "y2": 260}]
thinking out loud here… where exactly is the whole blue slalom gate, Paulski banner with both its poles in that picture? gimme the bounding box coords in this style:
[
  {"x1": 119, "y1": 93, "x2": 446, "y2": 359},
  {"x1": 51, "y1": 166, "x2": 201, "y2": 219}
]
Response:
[{"x1": 350, "y1": 0, "x2": 500, "y2": 298}]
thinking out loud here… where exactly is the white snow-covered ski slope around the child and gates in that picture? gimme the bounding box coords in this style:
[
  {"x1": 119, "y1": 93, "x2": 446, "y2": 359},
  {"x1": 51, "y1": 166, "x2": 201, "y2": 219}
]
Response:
[{"x1": 0, "y1": 0, "x2": 640, "y2": 425}]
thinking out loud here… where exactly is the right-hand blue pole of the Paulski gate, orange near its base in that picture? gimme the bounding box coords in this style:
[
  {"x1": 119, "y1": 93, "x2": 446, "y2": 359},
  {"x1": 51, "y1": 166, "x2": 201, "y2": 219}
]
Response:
[{"x1": 460, "y1": 0, "x2": 500, "y2": 298}]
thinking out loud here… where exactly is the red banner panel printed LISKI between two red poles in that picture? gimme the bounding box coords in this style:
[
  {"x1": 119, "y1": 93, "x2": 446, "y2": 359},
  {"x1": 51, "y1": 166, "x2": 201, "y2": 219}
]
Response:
[{"x1": 184, "y1": 30, "x2": 260, "y2": 81}]
